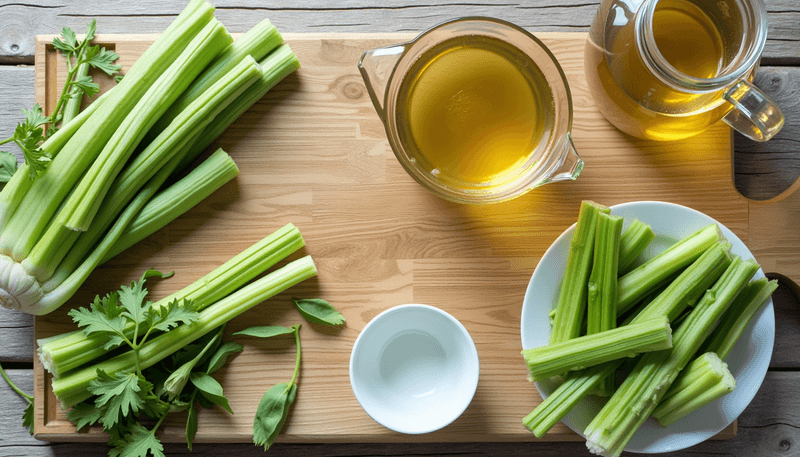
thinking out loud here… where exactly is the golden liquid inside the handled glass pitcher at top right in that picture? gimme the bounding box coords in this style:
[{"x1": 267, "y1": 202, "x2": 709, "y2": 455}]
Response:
[{"x1": 585, "y1": 0, "x2": 731, "y2": 140}]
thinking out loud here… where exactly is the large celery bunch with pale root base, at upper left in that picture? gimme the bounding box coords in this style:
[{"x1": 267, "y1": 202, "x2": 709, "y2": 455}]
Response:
[{"x1": 0, "y1": 0, "x2": 299, "y2": 315}]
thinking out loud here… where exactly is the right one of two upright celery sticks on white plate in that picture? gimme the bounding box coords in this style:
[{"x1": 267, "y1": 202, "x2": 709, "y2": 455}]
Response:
[{"x1": 586, "y1": 213, "x2": 623, "y2": 397}]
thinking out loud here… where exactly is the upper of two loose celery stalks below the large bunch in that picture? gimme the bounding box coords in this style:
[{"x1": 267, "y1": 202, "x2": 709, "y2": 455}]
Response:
[{"x1": 38, "y1": 224, "x2": 305, "y2": 377}]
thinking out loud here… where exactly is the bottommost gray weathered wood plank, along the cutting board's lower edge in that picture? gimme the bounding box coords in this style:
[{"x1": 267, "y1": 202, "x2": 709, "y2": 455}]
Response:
[{"x1": 0, "y1": 370, "x2": 800, "y2": 457}]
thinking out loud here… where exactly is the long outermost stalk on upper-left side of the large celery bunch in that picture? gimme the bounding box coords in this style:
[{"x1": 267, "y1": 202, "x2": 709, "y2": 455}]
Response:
[{"x1": 0, "y1": 1, "x2": 214, "y2": 261}]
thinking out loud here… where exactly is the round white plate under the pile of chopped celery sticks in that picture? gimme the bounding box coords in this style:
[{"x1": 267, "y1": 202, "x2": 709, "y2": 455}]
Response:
[{"x1": 520, "y1": 202, "x2": 775, "y2": 453}]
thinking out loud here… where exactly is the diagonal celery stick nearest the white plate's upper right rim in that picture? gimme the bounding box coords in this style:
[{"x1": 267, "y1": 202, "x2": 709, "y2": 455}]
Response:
[{"x1": 617, "y1": 224, "x2": 722, "y2": 314}]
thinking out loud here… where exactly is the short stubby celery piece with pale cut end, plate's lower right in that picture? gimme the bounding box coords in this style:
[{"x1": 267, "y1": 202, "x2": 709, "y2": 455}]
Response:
[{"x1": 653, "y1": 352, "x2": 736, "y2": 427}]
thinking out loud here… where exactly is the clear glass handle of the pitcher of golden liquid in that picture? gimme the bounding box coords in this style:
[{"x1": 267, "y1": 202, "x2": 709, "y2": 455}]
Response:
[{"x1": 722, "y1": 79, "x2": 784, "y2": 141}]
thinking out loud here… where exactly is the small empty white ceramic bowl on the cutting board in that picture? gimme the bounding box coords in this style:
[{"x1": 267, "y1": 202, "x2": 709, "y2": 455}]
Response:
[{"x1": 350, "y1": 305, "x2": 479, "y2": 434}]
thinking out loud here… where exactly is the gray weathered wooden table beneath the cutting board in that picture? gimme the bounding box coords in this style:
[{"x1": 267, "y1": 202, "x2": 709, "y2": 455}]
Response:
[{"x1": 0, "y1": 0, "x2": 800, "y2": 457}]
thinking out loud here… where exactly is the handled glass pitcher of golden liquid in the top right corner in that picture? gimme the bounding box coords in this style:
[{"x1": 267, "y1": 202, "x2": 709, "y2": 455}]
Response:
[{"x1": 584, "y1": 0, "x2": 784, "y2": 141}]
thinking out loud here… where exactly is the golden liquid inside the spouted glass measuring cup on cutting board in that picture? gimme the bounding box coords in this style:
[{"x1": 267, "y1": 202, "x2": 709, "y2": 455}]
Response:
[{"x1": 396, "y1": 36, "x2": 555, "y2": 189}]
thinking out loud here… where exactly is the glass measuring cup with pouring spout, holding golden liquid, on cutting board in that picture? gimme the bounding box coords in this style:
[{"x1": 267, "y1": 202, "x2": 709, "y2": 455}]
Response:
[{"x1": 358, "y1": 17, "x2": 583, "y2": 203}]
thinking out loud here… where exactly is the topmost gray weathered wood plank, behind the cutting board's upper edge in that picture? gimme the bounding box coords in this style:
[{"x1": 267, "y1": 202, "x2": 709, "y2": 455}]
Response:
[{"x1": 0, "y1": 0, "x2": 800, "y2": 64}]
